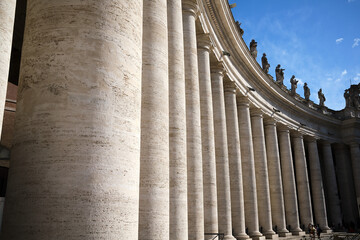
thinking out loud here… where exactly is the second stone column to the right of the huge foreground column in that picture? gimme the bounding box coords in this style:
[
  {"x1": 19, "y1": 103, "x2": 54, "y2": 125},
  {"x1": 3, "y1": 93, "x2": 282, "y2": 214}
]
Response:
[{"x1": 167, "y1": 0, "x2": 188, "y2": 240}]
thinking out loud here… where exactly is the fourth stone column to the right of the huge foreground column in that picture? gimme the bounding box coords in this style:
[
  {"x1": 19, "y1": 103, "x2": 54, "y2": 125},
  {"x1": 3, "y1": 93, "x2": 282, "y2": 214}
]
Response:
[{"x1": 198, "y1": 34, "x2": 219, "y2": 239}]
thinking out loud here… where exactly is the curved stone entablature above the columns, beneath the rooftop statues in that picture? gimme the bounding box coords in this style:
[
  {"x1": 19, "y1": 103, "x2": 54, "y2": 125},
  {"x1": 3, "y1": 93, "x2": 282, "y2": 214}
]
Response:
[{"x1": 198, "y1": 0, "x2": 350, "y2": 142}]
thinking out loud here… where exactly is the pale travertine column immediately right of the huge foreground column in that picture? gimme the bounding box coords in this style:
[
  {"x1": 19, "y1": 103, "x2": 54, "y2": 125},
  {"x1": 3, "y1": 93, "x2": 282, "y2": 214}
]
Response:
[{"x1": 138, "y1": 0, "x2": 170, "y2": 240}]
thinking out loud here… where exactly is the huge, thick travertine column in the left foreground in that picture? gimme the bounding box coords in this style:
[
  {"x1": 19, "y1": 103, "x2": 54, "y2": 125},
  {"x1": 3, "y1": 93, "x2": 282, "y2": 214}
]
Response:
[{"x1": 0, "y1": 0, "x2": 143, "y2": 240}]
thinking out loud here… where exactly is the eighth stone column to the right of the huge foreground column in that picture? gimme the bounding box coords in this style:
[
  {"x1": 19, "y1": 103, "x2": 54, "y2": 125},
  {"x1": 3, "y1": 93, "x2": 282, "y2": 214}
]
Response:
[{"x1": 251, "y1": 109, "x2": 278, "y2": 239}]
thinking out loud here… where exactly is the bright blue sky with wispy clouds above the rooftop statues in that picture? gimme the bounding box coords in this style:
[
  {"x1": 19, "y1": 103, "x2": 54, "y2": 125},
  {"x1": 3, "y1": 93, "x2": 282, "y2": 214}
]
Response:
[{"x1": 229, "y1": 0, "x2": 360, "y2": 110}]
